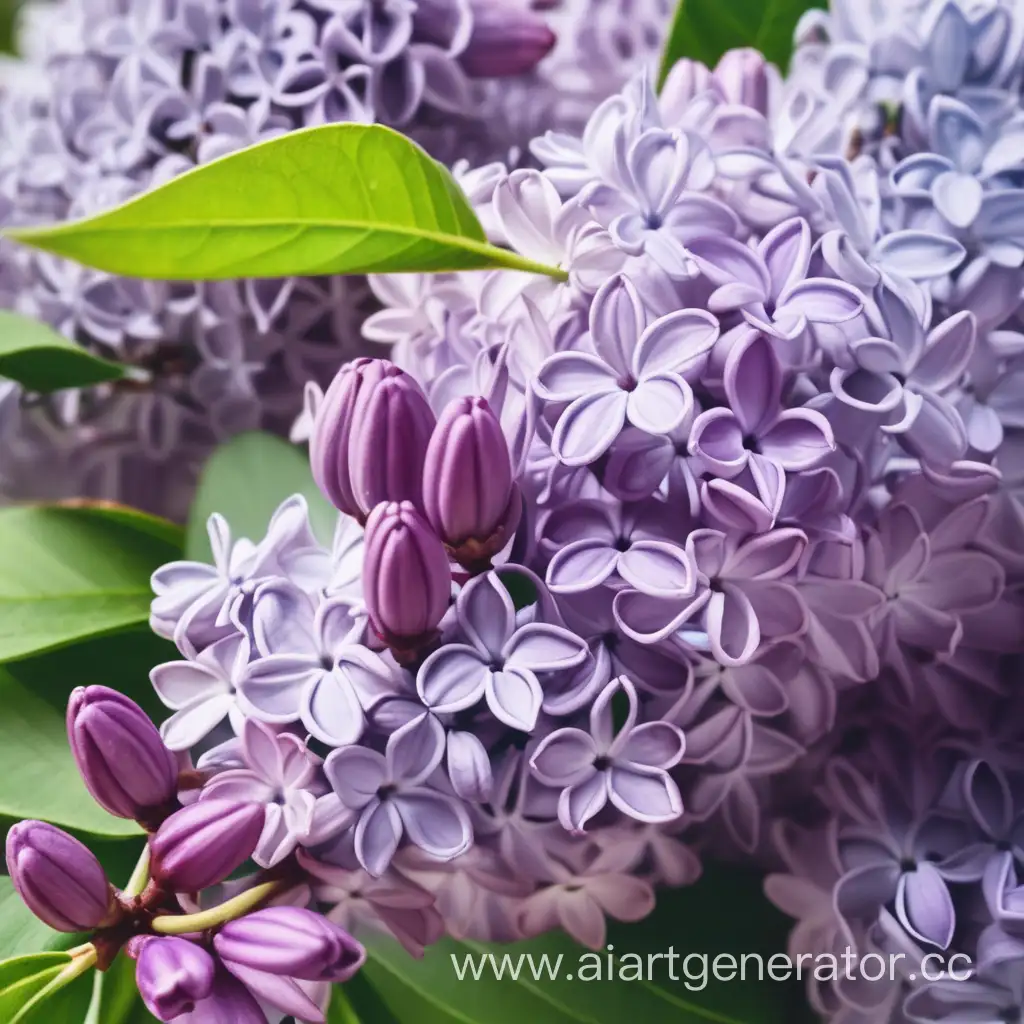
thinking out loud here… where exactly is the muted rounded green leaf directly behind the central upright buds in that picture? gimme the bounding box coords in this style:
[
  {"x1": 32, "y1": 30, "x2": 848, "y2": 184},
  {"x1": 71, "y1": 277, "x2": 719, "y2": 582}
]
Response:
[{"x1": 185, "y1": 432, "x2": 338, "y2": 561}]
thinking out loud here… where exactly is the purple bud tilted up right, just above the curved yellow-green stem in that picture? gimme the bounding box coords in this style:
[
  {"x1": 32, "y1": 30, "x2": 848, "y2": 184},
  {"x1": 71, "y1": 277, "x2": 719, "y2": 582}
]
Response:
[{"x1": 150, "y1": 800, "x2": 266, "y2": 893}]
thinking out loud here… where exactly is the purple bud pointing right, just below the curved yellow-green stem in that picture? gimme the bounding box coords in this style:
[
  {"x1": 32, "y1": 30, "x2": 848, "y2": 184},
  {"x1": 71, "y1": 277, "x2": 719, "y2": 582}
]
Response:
[{"x1": 213, "y1": 906, "x2": 367, "y2": 982}]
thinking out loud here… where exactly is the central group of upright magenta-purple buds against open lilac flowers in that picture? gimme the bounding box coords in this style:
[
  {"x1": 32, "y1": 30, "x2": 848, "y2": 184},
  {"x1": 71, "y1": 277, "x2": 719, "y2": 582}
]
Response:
[{"x1": 310, "y1": 358, "x2": 522, "y2": 665}]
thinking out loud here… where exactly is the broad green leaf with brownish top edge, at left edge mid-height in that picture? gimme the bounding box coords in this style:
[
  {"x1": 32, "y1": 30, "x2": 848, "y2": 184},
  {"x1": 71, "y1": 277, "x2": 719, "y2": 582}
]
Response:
[{"x1": 0, "y1": 507, "x2": 180, "y2": 662}]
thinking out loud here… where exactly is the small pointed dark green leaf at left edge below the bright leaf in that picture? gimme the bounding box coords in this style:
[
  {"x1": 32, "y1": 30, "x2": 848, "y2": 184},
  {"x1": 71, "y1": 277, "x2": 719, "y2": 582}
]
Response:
[{"x1": 0, "y1": 309, "x2": 125, "y2": 393}]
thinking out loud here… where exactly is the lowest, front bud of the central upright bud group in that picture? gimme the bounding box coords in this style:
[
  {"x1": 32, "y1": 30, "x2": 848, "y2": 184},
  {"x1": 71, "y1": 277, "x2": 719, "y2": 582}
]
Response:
[{"x1": 362, "y1": 502, "x2": 452, "y2": 649}]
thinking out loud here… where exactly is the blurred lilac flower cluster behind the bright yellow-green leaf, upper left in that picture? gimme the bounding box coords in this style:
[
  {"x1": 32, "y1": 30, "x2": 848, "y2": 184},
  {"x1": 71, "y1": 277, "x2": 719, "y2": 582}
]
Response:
[{"x1": 0, "y1": 0, "x2": 554, "y2": 518}]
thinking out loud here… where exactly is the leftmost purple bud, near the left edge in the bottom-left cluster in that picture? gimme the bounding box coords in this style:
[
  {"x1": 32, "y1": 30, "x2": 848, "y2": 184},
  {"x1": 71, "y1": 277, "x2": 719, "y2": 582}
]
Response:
[{"x1": 7, "y1": 821, "x2": 117, "y2": 932}]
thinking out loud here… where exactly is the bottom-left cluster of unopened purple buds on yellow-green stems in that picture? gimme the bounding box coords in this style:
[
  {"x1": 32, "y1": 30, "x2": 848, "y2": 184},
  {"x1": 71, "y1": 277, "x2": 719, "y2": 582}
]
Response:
[{"x1": 7, "y1": 686, "x2": 366, "y2": 1024}]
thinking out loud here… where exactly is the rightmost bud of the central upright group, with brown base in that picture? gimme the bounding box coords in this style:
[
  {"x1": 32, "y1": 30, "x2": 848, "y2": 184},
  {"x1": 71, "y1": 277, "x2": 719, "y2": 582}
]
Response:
[{"x1": 423, "y1": 397, "x2": 521, "y2": 560}]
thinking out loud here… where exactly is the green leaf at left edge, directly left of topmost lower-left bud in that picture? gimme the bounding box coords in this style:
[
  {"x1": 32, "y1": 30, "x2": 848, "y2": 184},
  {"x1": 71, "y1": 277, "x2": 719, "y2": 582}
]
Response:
[{"x1": 0, "y1": 670, "x2": 139, "y2": 836}]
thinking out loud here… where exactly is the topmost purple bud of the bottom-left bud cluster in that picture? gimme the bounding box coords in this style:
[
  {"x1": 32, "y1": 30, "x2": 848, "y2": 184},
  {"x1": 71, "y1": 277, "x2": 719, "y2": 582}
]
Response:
[{"x1": 68, "y1": 686, "x2": 178, "y2": 820}]
